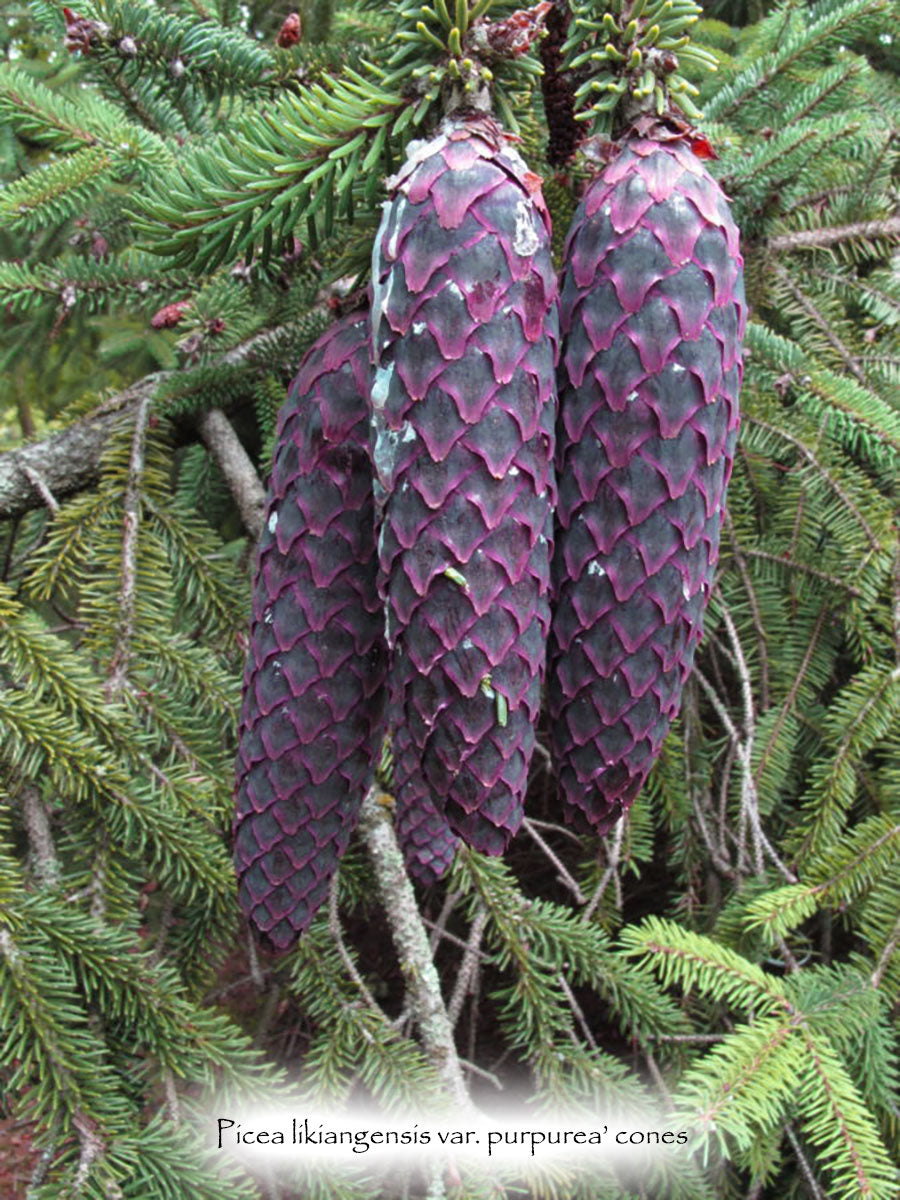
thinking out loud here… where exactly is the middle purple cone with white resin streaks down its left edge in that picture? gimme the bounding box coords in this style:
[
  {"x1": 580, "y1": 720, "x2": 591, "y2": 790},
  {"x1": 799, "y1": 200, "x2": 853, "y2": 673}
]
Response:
[{"x1": 372, "y1": 116, "x2": 558, "y2": 854}]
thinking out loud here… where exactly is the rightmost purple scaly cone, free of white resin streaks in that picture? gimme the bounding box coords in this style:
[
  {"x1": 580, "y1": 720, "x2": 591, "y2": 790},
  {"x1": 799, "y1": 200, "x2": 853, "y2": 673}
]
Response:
[{"x1": 550, "y1": 136, "x2": 745, "y2": 832}]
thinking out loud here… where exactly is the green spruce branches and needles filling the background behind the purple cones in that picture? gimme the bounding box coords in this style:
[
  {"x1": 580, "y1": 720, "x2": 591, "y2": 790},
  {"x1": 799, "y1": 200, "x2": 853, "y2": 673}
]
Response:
[{"x1": 0, "y1": 0, "x2": 900, "y2": 1200}]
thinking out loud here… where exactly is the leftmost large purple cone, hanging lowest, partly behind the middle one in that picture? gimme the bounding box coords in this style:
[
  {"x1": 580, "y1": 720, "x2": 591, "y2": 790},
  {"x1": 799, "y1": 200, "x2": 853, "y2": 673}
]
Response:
[{"x1": 234, "y1": 313, "x2": 385, "y2": 950}]
